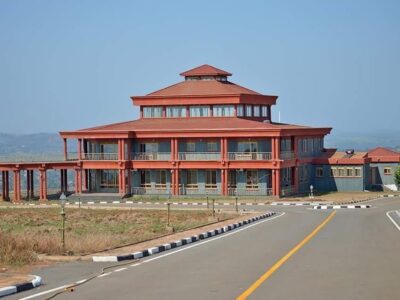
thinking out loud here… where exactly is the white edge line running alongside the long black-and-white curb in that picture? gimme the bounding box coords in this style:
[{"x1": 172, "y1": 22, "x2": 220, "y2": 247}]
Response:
[{"x1": 20, "y1": 212, "x2": 285, "y2": 300}]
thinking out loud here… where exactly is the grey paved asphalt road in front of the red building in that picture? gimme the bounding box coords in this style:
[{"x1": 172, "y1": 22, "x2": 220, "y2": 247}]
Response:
[{"x1": 7, "y1": 198, "x2": 400, "y2": 300}]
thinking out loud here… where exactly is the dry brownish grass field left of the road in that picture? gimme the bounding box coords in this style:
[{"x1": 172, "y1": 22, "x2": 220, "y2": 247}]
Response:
[{"x1": 0, "y1": 208, "x2": 236, "y2": 266}]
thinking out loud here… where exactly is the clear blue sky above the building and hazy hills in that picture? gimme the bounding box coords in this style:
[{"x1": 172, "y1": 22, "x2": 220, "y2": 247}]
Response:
[{"x1": 0, "y1": 0, "x2": 400, "y2": 133}]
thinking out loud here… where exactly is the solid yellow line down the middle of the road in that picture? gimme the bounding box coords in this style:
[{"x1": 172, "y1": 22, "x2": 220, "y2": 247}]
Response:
[{"x1": 236, "y1": 211, "x2": 336, "y2": 300}]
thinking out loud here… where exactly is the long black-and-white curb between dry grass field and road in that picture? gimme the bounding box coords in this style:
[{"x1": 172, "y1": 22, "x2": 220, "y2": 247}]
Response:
[{"x1": 92, "y1": 212, "x2": 276, "y2": 262}]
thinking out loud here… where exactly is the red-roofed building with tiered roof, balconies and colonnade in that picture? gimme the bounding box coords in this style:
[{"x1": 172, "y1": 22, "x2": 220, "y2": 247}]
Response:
[{"x1": 0, "y1": 65, "x2": 400, "y2": 201}]
